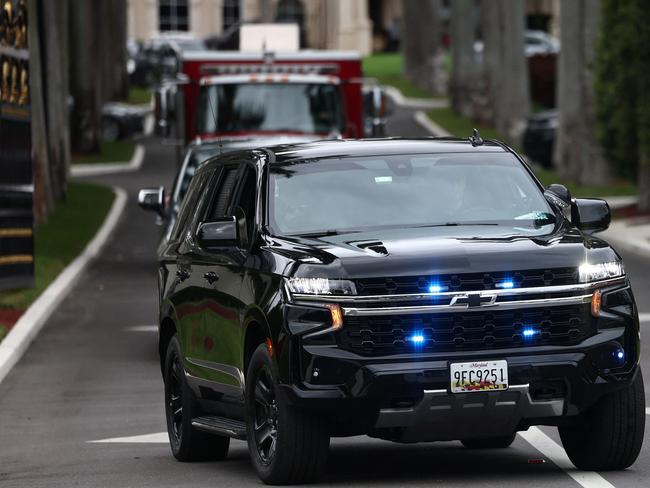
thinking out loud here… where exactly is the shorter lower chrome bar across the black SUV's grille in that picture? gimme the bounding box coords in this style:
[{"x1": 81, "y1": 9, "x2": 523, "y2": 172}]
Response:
[{"x1": 343, "y1": 294, "x2": 592, "y2": 316}]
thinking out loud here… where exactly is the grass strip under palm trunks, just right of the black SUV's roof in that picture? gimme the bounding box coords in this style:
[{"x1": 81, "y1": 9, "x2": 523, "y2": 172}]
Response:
[{"x1": 427, "y1": 108, "x2": 637, "y2": 197}]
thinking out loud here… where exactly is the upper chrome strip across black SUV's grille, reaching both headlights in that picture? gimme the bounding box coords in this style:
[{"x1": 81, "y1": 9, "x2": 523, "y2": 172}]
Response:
[{"x1": 287, "y1": 276, "x2": 626, "y2": 308}]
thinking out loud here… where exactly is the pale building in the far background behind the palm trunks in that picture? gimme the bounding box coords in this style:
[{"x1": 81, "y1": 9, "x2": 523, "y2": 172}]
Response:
[{"x1": 128, "y1": 0, "x2": 560, "y2": 54}]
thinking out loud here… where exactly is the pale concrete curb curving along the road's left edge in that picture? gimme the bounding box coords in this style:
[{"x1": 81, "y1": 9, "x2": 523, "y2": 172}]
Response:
[{"x1": 0, "y1": 187, "x2": 127, "y2": 383}]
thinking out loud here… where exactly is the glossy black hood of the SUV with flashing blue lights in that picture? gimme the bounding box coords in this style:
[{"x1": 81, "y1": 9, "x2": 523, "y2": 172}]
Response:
[{"x1": 269, "y1": 223, "x2": 620, "y2": 279}]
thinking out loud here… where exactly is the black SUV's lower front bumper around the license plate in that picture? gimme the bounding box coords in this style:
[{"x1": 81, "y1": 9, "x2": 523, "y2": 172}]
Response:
[{"x1": 282, "y1": 320, "x2": 638, "y2": 442}]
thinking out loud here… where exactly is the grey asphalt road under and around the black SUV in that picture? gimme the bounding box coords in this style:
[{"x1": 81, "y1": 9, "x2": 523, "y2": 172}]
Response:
[{"x1": 0, "y1": 111, "x2": 650, "y2": 488}]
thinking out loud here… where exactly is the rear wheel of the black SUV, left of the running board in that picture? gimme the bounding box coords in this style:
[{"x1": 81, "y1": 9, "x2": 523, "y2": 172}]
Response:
[{"x1": 165, "y1": 336, "x2": 230, "y2": 462}]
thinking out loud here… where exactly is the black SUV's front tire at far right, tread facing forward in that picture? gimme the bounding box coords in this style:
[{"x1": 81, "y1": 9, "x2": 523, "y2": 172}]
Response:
[{"x1": 559, "y1": 370, "x2": 645, "y2": 471}]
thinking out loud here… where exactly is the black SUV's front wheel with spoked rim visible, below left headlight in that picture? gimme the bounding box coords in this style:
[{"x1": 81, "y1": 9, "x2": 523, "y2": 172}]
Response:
[{"x1": 246, "y1": 344, "x2": 329, "y2": 485}]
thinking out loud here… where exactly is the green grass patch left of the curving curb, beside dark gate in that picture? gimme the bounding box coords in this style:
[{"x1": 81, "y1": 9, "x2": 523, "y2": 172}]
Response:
[{"x1": 0, "y1": 182, "x2": 114, "y2": 338}]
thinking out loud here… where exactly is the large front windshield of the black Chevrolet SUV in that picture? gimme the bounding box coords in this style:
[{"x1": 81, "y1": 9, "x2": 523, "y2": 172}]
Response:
[{"x1": 269, "y1": 153, "x2": 555, "y2": 235}]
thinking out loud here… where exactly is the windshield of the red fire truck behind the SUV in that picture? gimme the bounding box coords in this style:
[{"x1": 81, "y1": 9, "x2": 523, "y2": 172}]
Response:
[{"x1": 197, "y1": 83, "x2": 344, "y2": 134}]
